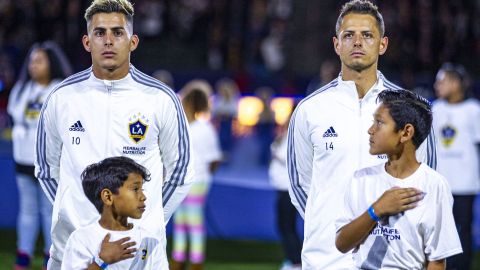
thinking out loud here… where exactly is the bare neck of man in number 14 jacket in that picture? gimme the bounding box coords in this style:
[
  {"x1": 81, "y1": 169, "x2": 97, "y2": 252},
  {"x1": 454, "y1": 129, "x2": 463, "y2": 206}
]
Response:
[{"x1": 342, "y1": 65, "x2": 377, "y2": 99}]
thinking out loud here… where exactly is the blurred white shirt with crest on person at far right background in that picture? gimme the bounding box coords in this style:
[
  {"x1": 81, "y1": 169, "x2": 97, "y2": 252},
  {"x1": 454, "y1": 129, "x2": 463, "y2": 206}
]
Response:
[{"x1": 432, "y1": 99, "x2": 480, "y2": 195}]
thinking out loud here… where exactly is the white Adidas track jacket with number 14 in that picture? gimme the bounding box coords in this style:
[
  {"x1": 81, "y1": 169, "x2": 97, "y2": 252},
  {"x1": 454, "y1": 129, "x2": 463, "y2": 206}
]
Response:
[{"x1": 287, "y1": 72, "x2": 436, "y2": 270}]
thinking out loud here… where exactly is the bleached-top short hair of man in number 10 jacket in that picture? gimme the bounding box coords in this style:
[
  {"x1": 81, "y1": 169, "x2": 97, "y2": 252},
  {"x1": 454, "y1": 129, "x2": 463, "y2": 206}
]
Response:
[{"x1": 85, "y1": 0, "x2": 134, "y2": 24}]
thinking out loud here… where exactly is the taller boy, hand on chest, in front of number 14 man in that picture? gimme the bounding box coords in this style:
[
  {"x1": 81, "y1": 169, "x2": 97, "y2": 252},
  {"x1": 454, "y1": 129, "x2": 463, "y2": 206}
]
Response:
[{"x1": 335, "y1": 90, "x2": 462, "y2": 270}]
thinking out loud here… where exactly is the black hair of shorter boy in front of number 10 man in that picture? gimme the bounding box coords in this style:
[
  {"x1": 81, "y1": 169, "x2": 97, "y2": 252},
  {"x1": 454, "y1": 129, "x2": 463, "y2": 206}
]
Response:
[{"x1": 81, "y1": 157, "x2": 150, "y2": 214}]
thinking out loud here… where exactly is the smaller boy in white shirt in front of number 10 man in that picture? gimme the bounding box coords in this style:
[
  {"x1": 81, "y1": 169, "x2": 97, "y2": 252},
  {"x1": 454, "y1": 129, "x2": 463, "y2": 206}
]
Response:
[{"x1": 62, "y1": 157, "x2": 166, "y2": 270}]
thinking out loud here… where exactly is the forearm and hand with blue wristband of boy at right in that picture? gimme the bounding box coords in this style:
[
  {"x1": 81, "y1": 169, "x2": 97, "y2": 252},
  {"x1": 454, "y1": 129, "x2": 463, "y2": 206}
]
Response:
[{"x1": 335, "y1": 187, "x2": 424, "y2": 253}]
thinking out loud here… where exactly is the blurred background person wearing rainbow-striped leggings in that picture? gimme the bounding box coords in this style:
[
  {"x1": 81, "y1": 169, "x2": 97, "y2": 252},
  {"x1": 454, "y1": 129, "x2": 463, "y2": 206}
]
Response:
[{"x1": 170, "y1": 80, "x2": 222, "y2": 270}]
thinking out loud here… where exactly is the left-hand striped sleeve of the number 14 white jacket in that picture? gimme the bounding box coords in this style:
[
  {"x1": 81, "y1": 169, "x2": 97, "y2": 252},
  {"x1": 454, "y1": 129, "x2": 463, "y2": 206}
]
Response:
[{"x1": 287, "y1": 106, "x2": 313, "y2": 218}]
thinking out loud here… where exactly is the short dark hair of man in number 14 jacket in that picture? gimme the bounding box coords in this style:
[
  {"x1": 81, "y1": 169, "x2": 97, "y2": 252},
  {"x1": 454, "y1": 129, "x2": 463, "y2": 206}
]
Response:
[{"x1": 335, "y1": 0, "x2": 385, "y2": 37}]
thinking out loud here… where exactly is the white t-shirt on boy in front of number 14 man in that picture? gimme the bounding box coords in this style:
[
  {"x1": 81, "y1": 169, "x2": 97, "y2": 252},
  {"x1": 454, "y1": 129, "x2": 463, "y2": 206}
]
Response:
[{"x1": 336, "y1": 164, "x2": 462, "y2": 270}]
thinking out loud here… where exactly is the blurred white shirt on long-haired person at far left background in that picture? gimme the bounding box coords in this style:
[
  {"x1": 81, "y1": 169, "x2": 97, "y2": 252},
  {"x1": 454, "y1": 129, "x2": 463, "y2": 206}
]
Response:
[{"x1": 7, "y1": 80, "x2": 60, "y2": 166}]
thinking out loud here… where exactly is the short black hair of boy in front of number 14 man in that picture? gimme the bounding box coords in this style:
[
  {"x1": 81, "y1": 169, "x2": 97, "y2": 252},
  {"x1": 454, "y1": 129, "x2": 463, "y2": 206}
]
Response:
[{"x1": 377, "y1": 90, "x2": 432, "y2": 148}]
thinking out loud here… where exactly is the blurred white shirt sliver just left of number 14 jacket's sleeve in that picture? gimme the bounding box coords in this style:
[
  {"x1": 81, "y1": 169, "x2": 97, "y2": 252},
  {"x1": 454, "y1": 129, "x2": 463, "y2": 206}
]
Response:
[{"x1": 268, "y1": 136, "x2": 290, "y2": 191}]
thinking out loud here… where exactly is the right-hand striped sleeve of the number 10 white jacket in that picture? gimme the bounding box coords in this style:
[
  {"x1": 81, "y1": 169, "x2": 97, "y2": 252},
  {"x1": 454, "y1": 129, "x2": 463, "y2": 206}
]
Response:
[{"x1": 159, "y1": 94, "x2": 193, "y2": 224}]
